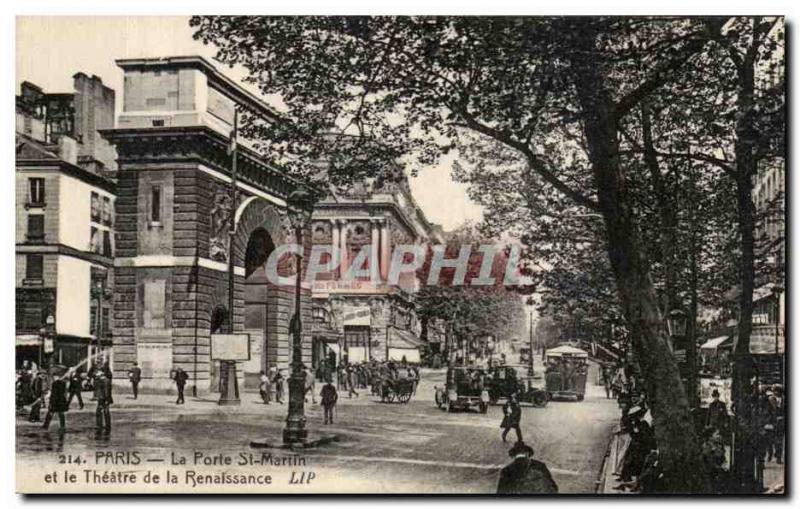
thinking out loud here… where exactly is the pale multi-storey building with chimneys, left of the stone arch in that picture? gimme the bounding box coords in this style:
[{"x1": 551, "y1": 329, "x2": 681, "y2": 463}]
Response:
[{"x1": 15, "y1": 73, "x2": 116, "y2": 367}]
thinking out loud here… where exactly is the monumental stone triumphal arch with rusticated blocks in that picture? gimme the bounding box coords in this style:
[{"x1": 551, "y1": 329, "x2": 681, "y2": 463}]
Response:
[{"x1": 108, "y1": 57, "x2": 311, "y2": 393}]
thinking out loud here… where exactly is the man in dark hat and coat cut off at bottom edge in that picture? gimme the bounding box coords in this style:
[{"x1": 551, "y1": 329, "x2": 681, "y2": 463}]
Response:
[{"x1": 497, "y1": 442, "x2": 558, "y2": 495}]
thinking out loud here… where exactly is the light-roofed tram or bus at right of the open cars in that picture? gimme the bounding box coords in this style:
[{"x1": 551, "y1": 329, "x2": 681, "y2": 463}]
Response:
[{"x1": 544, "y1": 345, "x2": 589, "y2": 401}]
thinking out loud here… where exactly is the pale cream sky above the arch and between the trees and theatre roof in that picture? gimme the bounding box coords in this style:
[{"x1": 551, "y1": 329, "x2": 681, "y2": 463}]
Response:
[{"x1": 16, "y1": 16, "x2": 483, "y2": 230}]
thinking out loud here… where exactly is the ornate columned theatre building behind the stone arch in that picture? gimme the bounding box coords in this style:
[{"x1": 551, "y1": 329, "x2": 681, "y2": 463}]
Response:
[{"x1": 312, "y1": 177, "x2": 443, "y2": 366}]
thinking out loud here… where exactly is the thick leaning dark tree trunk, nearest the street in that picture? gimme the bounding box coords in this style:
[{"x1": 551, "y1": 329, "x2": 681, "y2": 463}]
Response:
[{"x1": 574, "y1": 45, "x2": 708, "y2": 493}]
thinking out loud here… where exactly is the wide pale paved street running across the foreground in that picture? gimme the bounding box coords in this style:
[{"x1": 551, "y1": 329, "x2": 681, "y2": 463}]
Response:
[{"x1": 17, "y1": 371, "x2": 617, "y2": 493}]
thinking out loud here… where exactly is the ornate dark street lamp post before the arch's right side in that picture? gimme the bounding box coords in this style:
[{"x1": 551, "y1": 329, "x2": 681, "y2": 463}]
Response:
[{"x1": 283, "y1": 188, "x2": 314, "y2": 446}]
